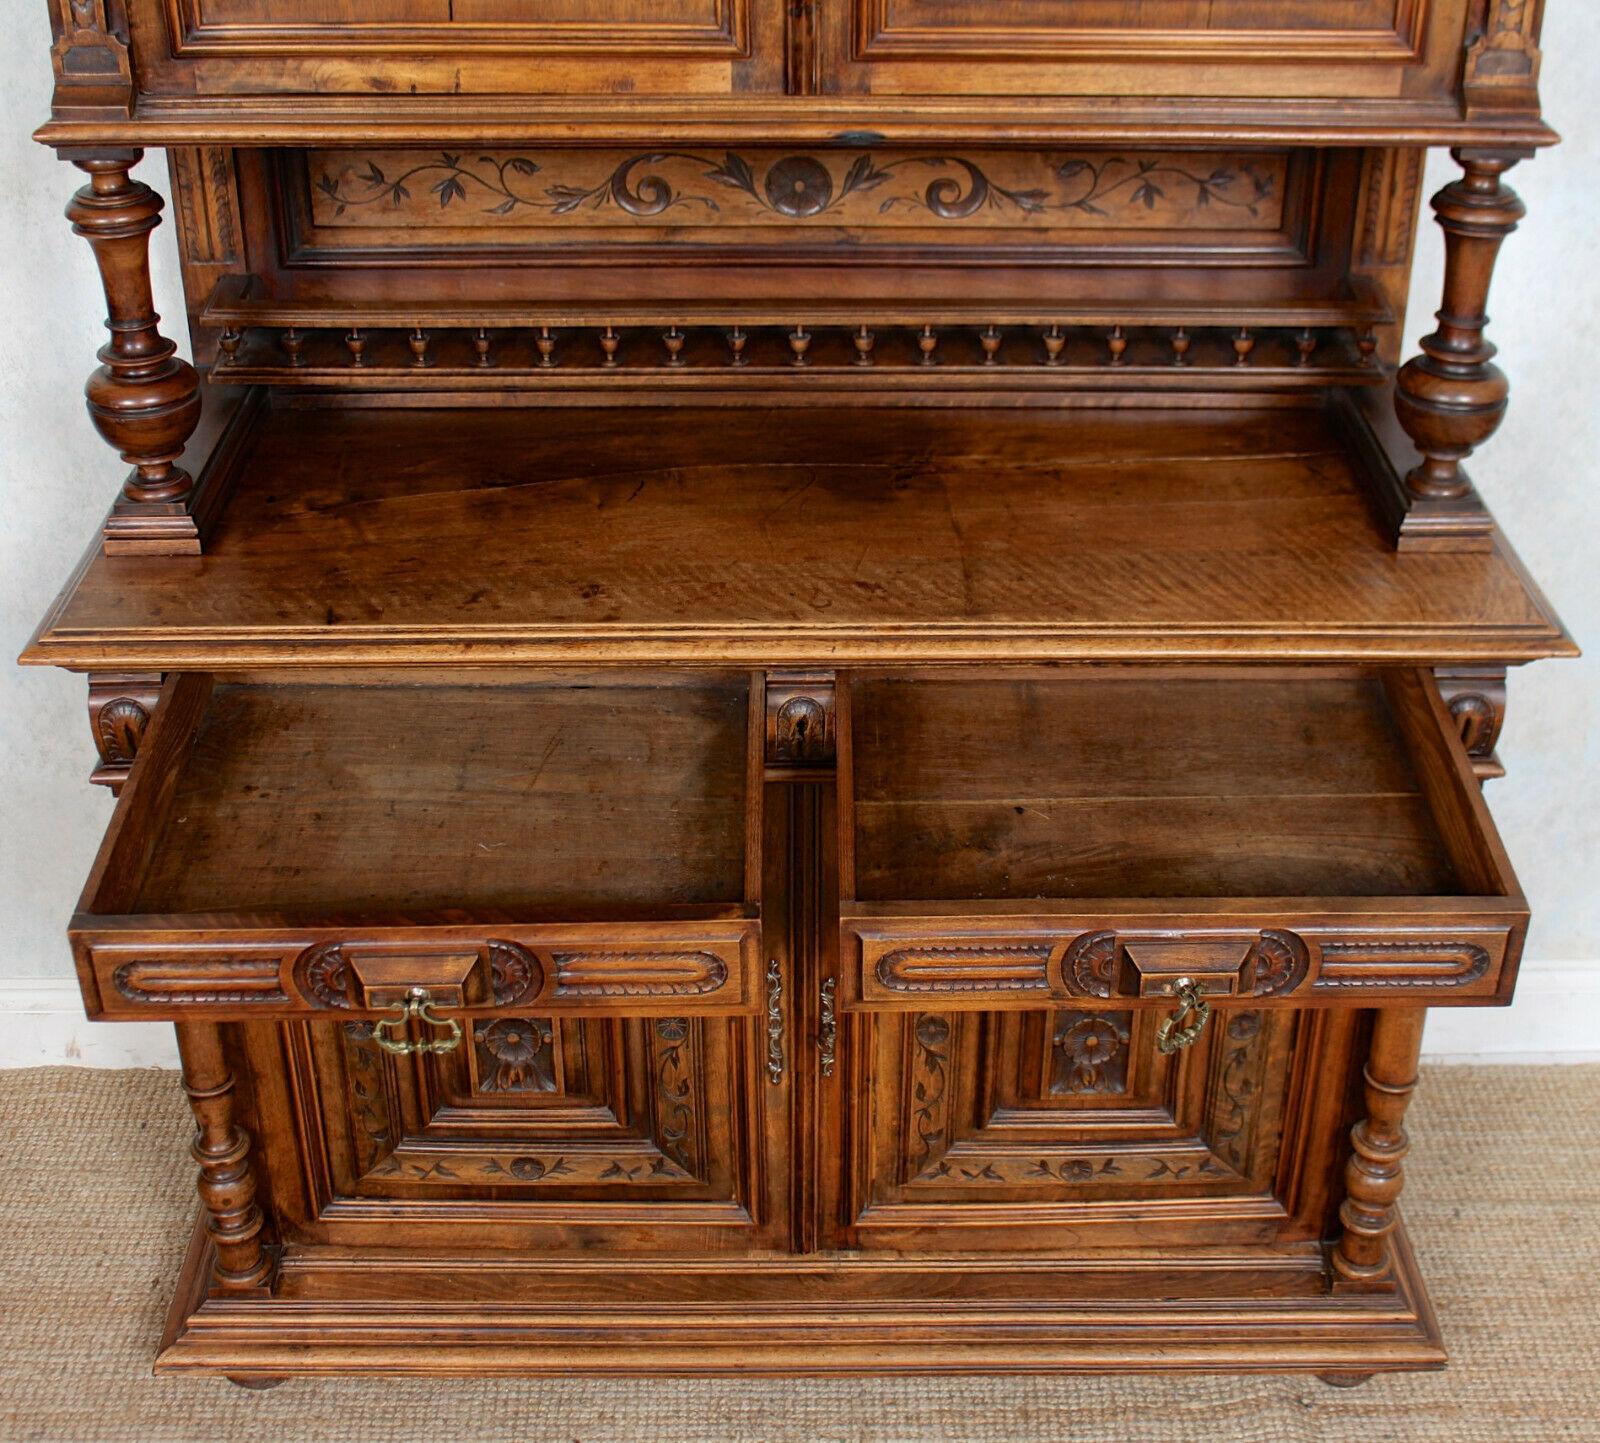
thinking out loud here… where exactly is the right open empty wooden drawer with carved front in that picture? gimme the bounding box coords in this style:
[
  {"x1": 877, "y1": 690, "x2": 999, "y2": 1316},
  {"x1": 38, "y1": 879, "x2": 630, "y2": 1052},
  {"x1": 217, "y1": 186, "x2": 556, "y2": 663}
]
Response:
[{"x1": 838, "y1": 667, "x2": 1528, "y2": 1011}]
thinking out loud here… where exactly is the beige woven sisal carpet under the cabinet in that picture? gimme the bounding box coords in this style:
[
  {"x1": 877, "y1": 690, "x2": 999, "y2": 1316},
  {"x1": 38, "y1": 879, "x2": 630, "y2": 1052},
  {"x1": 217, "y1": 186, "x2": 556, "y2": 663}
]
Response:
[{"x1": 0, "y1": 1067, "x2": 1600, "y2": 1443}]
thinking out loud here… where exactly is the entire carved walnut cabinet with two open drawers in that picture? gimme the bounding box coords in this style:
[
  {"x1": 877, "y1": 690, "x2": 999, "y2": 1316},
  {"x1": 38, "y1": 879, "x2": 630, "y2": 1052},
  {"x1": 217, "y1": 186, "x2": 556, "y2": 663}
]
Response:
[{"x1": 24, "y1": 0, "x2": 1573, "y2": 1384}]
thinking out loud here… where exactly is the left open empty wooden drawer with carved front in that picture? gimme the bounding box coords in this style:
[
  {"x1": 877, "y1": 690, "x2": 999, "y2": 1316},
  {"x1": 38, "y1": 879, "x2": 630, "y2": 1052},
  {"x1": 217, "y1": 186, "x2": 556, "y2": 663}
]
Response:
[{"x1": 72, "y1": 672, "x2": 762, "y2": 1037}]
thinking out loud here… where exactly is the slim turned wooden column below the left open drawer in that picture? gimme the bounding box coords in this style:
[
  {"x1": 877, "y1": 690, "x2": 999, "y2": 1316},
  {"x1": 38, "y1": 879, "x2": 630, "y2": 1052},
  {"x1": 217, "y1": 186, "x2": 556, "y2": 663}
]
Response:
[{"x1": 178, "y1": 1022, "x2": 272, "y2": 1293}]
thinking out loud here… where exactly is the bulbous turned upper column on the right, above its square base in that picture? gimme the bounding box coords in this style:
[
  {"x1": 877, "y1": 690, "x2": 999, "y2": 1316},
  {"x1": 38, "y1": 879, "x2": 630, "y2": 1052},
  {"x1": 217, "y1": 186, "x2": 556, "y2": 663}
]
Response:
[{"x1": 1395, "y1": 150, "x2": 1525, "y2": 499}]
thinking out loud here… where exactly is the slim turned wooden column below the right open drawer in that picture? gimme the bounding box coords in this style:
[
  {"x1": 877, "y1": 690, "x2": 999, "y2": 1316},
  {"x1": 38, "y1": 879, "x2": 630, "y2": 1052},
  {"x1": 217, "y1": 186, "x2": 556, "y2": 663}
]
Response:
[{"x1": 1333, "y1": 1008, "x2": 1427, "y2": 1289}]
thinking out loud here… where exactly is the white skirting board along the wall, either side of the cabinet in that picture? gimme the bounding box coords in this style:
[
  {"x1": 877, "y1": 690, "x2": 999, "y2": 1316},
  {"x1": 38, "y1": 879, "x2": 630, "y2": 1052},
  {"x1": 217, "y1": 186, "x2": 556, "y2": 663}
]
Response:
[{"x1": 0, "y1": 961, "x2": 1600, "y2": 1067}]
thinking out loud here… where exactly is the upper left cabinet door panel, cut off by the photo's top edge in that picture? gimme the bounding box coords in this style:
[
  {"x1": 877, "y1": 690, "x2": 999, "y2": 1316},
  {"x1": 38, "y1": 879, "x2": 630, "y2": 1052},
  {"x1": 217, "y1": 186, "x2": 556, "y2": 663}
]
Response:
[{"x1": 147, "y1": 0, "x2": 784, "y2": 98}]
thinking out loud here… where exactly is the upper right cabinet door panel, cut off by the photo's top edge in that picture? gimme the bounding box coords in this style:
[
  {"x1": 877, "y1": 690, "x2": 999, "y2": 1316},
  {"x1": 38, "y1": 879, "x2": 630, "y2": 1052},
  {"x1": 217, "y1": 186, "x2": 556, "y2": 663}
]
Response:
[{"x1": 822, "y1": 0, "x2": 1467, "y2": 99}]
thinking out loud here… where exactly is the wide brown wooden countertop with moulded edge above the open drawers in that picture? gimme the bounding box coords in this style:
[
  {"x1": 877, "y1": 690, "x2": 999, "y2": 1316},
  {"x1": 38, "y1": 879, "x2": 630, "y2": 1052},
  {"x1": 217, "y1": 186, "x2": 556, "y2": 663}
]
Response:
[{"x1": 24, "y1": 397, "x2": 1574, "y2": 670}]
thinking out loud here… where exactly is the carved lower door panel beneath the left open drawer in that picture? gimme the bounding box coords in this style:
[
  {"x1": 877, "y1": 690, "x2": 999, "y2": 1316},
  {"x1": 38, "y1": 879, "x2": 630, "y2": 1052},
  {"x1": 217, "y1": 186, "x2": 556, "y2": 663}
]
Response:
[{"x1": 258, "y1": 1016, "x2": 778, "y2": 1253}]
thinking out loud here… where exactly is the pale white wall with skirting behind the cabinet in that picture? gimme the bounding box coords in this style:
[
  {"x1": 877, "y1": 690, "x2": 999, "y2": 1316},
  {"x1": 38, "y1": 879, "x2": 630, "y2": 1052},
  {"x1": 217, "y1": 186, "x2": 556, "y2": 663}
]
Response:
[{"x1": 0, "y1": 0, "x2": 1600, "y2": 1065}]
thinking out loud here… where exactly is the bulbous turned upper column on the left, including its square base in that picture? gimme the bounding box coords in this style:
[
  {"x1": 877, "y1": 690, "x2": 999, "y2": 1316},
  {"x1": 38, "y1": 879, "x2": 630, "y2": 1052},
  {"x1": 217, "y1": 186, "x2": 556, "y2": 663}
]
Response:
[{"x1": 67, "y1": 150, "x2": 200, "y2": 552}]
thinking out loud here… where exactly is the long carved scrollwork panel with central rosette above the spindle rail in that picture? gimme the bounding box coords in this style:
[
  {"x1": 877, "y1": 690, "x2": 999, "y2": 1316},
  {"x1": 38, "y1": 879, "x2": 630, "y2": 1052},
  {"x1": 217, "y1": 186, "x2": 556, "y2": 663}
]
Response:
[{"x1": 296, "y1": 147, "x2": 1293, "y2": 245}]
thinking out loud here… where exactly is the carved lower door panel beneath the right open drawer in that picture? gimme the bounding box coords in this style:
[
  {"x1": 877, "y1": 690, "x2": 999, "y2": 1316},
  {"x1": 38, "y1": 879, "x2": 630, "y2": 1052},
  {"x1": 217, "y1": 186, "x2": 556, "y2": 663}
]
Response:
[{"x1": 829, "y1": 1008, "x2": 1350, "y2": 1253}]
